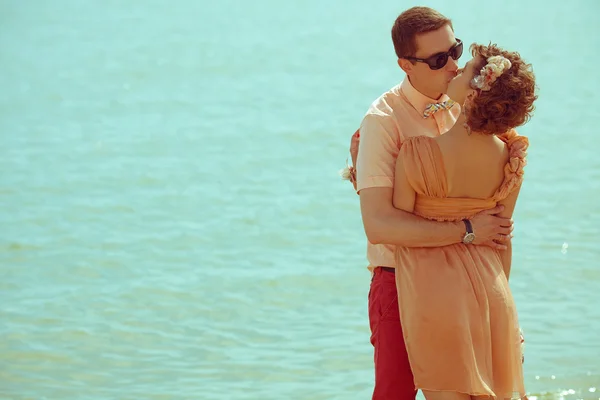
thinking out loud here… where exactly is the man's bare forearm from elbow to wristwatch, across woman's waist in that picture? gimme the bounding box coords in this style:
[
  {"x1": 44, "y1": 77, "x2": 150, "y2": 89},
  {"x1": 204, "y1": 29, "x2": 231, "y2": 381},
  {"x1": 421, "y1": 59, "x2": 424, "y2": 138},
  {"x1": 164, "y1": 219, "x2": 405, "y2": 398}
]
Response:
[{"x1": 367, "y1": 208, "x2": 465, "y2": 247}]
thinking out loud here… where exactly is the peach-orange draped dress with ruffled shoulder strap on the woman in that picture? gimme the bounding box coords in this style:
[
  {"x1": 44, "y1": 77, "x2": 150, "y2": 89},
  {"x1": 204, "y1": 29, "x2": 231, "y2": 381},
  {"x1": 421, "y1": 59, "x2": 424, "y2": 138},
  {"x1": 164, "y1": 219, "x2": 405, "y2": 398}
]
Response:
[{"x1": 395, "y1": 131, "x2": 528, "y2": 399}]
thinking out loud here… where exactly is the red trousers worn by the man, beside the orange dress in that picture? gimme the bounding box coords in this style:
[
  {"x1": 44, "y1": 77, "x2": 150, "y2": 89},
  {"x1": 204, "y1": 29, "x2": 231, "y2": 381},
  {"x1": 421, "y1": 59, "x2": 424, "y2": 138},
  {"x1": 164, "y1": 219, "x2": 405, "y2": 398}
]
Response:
[{"x1": 369, "y1": 268, "x2": 417, "y2": 400}]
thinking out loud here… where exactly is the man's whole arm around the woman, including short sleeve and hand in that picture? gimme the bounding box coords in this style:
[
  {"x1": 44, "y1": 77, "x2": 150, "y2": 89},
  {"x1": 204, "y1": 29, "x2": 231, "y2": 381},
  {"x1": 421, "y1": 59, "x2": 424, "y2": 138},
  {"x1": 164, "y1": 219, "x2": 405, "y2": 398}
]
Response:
[{"x1": 356, "y1": 115, "x2": 512, "y2": 249}]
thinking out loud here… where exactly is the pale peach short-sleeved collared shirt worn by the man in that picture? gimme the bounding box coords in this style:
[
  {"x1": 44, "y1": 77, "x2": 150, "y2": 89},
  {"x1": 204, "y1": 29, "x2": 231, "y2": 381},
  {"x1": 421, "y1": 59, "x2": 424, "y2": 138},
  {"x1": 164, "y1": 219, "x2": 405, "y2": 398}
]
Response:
[{"x1": 356, "y1": 77, "x2": 460, "y2": 270}]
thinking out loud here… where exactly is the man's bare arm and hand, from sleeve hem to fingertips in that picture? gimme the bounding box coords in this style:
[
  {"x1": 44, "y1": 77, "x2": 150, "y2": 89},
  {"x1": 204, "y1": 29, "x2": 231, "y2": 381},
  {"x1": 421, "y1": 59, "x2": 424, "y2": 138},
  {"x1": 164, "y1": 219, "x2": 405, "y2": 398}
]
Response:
[{"x1": 359, "y1": 187, "x2": 512, "y2": 250}]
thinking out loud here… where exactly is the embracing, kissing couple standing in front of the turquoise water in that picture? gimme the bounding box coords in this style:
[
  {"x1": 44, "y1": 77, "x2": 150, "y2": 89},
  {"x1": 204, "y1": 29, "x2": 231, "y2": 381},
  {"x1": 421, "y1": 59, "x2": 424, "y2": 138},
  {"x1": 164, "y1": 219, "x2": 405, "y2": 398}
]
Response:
[{"x1": 346, "y1": 7, "x2": 537, "y2": 400}]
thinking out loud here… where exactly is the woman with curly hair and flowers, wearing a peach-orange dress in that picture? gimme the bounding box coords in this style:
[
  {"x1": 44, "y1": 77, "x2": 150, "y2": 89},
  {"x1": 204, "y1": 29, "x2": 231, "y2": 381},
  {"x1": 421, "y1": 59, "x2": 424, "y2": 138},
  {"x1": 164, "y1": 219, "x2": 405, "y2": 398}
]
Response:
[{"x1": 394, "y1": 45, "x2": 537, "y2": 400}]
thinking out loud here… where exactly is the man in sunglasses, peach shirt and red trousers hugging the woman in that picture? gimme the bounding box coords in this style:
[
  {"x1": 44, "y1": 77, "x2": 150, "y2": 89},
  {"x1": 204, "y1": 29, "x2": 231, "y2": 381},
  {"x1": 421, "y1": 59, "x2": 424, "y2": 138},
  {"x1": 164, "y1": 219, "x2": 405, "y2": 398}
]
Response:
[{"x1": 350, "y1": 7, "x2": 512, "y2": 400}]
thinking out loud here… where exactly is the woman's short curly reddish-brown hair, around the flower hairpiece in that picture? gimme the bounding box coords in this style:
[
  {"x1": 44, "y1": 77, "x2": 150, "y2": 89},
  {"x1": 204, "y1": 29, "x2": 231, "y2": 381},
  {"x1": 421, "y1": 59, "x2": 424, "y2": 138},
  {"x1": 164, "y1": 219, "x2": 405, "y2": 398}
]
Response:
[{"x1": 465, "y1": 44, "x2": 538, "y2": 134}]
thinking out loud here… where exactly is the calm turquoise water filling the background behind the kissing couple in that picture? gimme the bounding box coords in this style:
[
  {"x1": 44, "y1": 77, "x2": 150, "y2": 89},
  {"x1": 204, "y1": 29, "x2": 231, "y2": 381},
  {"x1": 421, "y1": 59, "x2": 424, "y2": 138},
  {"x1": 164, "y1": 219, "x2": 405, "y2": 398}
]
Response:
[{"x1": 0, "y1": 0, "x2": 600, "y2": 400}]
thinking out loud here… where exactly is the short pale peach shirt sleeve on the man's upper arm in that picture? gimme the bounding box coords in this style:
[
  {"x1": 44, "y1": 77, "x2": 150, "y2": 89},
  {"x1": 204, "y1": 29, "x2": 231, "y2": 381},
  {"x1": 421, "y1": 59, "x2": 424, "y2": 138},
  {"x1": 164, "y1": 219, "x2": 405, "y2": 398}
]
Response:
[{"x1": 356, "y1": 114, "x2": 400, "y2": 191}]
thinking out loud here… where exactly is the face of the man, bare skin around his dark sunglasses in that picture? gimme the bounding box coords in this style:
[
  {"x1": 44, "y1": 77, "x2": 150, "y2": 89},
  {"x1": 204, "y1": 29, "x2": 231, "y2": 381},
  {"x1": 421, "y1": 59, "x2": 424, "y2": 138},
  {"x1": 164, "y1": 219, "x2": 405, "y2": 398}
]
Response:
[{"x1": 409, "y1": 25, "x2": 458, "y2": 94}]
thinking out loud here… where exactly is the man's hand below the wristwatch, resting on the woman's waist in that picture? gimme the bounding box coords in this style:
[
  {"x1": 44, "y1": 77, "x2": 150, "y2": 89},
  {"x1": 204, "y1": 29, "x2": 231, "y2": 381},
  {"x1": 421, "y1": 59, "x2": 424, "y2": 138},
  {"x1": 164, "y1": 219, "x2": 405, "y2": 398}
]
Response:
[{"x1": 471, "y1": 205, "x2": 514, "y2": 250}]
